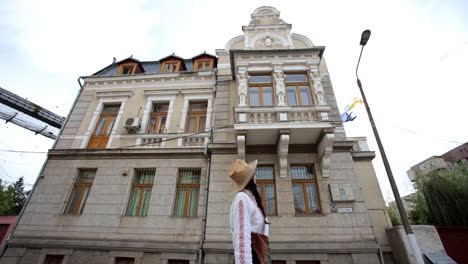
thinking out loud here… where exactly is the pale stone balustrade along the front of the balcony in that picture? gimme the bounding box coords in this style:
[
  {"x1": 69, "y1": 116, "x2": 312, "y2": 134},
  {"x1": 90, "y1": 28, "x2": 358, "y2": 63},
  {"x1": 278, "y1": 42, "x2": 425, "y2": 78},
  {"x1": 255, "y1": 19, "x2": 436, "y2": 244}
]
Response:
[{"x1": 235, "y1": 106, "x2": 330, "y2": 124}]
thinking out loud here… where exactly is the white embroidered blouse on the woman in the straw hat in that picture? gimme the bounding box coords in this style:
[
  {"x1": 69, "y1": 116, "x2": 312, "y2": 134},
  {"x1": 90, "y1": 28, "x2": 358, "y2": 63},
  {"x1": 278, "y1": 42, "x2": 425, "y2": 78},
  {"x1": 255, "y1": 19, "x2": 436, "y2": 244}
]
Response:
[{"x1": 229, "y1": 189, "x2": 268, "y2": 264}]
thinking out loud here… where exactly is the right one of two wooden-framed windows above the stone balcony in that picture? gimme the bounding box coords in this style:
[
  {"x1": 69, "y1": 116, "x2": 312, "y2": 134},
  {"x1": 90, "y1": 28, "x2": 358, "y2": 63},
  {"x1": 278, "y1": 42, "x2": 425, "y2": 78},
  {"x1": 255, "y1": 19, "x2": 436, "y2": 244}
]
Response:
[{"x1": 285, "y1": 73, "x2": 312, "y2": 106}]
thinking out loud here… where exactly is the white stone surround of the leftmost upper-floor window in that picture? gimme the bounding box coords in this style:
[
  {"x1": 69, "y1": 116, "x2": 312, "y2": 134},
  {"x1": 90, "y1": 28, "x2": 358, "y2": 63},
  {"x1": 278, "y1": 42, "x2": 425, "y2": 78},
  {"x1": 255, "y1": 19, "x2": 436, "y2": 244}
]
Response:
[{"x1": 80, "y1": 91, "x2": 133, "y2": 149}]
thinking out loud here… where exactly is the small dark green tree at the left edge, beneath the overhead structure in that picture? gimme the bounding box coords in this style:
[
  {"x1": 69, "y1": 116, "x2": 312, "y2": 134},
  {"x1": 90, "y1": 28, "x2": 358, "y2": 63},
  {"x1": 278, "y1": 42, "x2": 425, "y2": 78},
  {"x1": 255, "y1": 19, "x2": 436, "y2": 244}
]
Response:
[{"x1": 0, "y1": 177, "x2": 29, "y2": 215}]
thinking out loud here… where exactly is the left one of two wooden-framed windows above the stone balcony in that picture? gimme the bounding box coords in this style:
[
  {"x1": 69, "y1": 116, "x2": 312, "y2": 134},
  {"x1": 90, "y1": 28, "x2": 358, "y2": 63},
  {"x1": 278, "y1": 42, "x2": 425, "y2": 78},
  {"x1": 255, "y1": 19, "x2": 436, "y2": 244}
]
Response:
[{"x1": 249, "y1": 75, "x2": 273, "y2": 106}]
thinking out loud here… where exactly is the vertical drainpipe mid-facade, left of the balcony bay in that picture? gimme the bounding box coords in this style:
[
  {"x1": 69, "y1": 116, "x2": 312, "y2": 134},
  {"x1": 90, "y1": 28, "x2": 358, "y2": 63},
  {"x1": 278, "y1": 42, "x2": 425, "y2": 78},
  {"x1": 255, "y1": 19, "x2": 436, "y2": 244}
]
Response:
[{"x1": 197, "y1": 69, "x2": 218, "y2": 264}]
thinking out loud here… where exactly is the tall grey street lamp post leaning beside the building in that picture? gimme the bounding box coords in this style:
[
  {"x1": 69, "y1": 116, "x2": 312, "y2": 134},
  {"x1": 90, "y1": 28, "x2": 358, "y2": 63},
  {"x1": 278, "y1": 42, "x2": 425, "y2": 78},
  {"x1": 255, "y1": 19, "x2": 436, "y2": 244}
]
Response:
[{"x1": 356, "y1": 29, "x2": 424, "y2": 264}]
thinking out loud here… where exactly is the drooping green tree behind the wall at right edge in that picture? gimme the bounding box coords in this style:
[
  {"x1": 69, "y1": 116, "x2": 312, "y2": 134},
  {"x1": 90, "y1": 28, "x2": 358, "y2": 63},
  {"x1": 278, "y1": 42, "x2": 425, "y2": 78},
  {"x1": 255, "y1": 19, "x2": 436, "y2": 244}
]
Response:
[{"x1": 409, "y1": 165, "x2": 468, "y2": 226}]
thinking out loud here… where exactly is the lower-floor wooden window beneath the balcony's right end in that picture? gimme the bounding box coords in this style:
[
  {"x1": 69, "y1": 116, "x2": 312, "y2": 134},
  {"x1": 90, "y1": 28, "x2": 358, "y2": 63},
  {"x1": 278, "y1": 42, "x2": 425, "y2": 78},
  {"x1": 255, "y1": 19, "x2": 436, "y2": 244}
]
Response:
[{"x1": 290, "y1": 164, "x2": 320, "y2": 215}]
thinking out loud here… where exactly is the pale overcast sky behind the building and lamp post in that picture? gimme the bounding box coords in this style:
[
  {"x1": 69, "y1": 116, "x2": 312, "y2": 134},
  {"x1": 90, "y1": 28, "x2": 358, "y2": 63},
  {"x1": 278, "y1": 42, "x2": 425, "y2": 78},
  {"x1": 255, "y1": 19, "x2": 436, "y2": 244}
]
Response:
[{"x1": 0, "y1": 0, "x2": 468, "y2": 199}]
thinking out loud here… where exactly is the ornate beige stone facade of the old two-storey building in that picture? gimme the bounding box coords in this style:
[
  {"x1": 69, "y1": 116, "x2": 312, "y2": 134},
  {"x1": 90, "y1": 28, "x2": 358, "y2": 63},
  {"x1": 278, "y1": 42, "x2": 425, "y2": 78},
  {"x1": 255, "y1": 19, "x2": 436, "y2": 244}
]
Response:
[{"x1": 0, "y1": 7, "x2": 391, "y2": 264}]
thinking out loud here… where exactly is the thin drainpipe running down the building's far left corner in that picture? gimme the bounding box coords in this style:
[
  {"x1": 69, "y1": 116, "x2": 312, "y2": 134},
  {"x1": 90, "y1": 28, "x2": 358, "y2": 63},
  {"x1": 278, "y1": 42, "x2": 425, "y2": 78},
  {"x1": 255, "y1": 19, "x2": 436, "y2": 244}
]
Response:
[{"x1": 0, "y1": 76, "x2": 83, "y2": 258}]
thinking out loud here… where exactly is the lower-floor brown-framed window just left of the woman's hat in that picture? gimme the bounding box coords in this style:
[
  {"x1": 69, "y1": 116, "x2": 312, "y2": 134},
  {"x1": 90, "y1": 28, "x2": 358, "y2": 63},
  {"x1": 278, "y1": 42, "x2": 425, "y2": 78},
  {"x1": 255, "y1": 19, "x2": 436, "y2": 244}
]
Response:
[{"x1": 174, "y1": 168, "x2": 201, "y2": 216}]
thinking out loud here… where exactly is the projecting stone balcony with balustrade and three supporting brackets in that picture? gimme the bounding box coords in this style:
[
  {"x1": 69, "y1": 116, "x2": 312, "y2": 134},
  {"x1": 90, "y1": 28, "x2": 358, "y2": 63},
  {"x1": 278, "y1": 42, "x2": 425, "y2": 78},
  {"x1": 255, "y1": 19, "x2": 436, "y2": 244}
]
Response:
[{"x1": 234, "y1": 105, "x2": 335, "y2": 178}]
